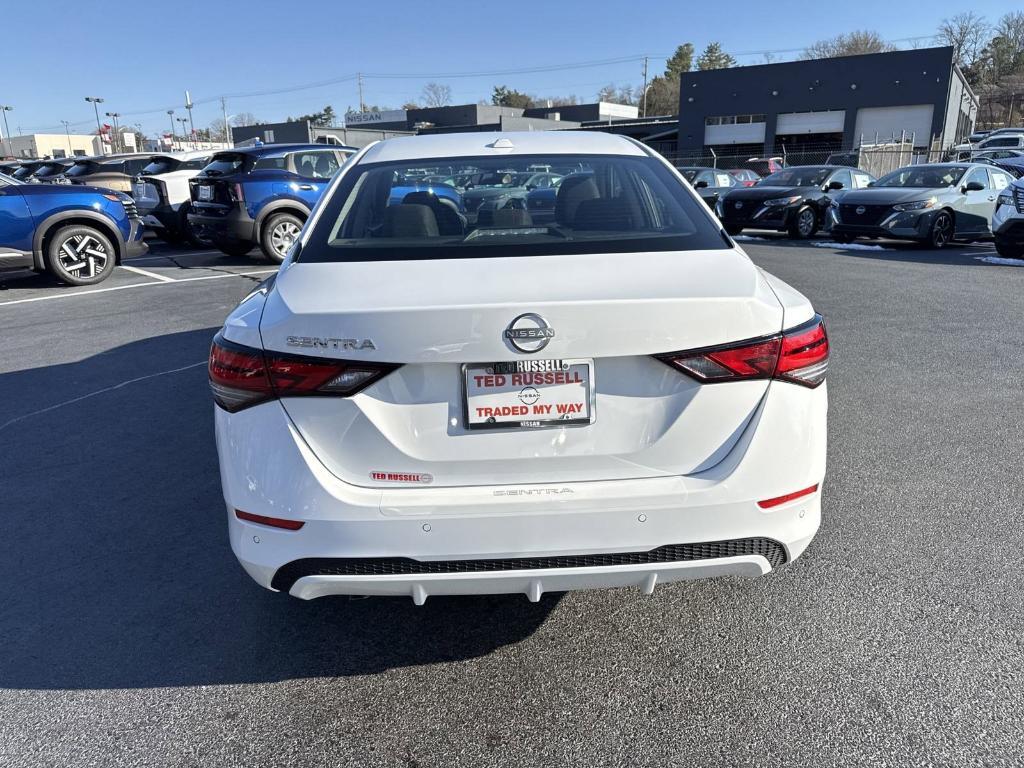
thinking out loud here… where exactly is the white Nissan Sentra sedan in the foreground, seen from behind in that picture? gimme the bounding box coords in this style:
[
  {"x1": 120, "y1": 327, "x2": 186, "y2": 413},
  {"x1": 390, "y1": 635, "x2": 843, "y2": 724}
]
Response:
[{"x1": 210, "y1": 131, "x2": 828, "y2": 603}]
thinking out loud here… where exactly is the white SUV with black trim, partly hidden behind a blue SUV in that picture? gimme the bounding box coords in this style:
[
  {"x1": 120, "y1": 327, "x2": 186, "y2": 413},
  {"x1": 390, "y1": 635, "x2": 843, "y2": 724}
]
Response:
[{"x1": 132, "y1": 150, "x2": 213, "y2": 245}]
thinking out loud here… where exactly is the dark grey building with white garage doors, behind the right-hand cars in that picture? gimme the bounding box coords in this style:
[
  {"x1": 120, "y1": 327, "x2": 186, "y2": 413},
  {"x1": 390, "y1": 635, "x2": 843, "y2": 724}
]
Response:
[{"x1": 677, "y1": 47, "x2": 978, "y2": 156}]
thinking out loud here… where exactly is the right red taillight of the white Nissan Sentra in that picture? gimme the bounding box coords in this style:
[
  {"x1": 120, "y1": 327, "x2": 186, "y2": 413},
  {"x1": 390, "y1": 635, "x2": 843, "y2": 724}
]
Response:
[{"x1": 658, "y1": 314, "x2": 828, "y2": 388}]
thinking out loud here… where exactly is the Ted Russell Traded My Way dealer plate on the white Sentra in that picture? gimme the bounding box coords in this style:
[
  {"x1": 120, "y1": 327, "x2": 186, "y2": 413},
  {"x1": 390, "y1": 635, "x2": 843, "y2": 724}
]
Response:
[{"x1": 463, "y1": 360, "x2": 594, "y2": 429}]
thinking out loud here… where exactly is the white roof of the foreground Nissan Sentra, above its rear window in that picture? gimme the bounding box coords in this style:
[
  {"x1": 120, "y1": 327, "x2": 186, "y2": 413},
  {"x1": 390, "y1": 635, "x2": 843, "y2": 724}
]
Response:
[{"x1": 362, "y1": 131, "x2": 647, "y2": 163}]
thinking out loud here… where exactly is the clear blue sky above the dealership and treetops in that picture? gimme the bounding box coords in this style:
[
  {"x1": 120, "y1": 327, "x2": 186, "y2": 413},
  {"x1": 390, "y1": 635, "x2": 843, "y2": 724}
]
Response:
[{"x1": 0, "y1": 0, "x2": 1018, "y2": 140}]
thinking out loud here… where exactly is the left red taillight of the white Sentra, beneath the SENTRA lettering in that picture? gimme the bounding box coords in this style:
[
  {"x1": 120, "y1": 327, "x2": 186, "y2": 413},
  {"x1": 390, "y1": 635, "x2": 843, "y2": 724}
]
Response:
[{"x1": 209, "y1": 334, "x2": 397, "y2": 412}]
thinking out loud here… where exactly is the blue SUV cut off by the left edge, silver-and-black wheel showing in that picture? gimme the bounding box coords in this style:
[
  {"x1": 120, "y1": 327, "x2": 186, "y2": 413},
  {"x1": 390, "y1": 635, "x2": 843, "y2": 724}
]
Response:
[{"x1": 0, "y1": 174, "x2": 147, "y2": 286}]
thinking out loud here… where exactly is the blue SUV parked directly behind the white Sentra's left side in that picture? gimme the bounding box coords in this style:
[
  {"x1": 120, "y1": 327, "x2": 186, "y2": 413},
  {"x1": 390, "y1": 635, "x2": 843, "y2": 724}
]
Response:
[{"x1": 188, "y1": 144, "x2": 356, "y2": 264}]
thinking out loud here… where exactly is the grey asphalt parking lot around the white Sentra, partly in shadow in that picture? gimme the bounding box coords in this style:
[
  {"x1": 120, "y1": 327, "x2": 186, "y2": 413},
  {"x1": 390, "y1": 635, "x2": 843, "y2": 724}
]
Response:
[{"x1": 0, "y1": 237, "x2": 1024, "y2": 768}]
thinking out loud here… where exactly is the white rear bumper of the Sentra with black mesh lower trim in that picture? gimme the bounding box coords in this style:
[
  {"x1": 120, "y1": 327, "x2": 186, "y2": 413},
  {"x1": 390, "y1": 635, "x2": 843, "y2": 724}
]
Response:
[{"x1": 216, "y1": 376, "x2": 827, "y2": 602}]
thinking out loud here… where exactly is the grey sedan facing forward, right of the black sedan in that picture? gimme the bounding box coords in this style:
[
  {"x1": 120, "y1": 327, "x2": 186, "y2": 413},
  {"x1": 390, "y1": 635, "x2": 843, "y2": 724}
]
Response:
[{"x1": 829, "y1": 163, "x2": 1013, "y2": 248}]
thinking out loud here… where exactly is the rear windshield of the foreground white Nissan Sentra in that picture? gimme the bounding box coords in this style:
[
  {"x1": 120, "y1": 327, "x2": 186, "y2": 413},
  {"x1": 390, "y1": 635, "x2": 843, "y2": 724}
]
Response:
[{"x1": 300, "y1": 155, "x2": 729, "y2": 261}]
